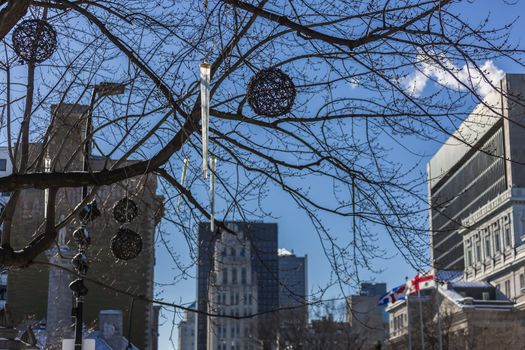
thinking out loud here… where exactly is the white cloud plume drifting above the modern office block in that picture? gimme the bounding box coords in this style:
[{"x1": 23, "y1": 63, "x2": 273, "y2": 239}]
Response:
[{"x1": 401, "y1": 54, "x2": 505, "y2": 97}]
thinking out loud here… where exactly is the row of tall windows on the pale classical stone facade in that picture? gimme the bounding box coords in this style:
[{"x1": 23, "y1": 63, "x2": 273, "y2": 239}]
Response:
[{"x1": 465, "y1": 215, "x2": 512, "y2": 266}]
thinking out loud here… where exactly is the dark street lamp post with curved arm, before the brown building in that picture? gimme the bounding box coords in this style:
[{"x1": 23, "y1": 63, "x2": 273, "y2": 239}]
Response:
[{"x1": 69, "y1": 82, "x2": 125, "y2": 350}]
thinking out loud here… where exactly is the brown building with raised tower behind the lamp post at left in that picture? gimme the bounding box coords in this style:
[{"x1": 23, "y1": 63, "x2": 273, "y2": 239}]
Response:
[{"x1": 0, "y1": 104, "x2": 162, "y2": 349}]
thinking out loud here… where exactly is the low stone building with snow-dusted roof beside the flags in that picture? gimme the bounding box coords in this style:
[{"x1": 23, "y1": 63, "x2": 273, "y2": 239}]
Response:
[{"x1": 387, "y1": 281, "x2": 525, "y2": 350}]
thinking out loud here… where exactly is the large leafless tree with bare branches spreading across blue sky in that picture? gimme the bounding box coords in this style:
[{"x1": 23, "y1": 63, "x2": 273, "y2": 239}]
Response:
[{"x1": 0, "y1": 0, "x2": 522, "y2": 328}]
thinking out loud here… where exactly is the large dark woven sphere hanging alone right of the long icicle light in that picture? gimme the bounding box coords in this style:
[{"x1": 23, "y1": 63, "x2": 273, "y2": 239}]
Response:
[{"x1": 246, "y1": 68, "x2": 296, "y2": 117}]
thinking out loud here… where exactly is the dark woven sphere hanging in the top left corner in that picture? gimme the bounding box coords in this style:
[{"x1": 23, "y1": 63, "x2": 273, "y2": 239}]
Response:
[{"x1": 12, "y1": 19, "x2": 57, "y2": 63}]
